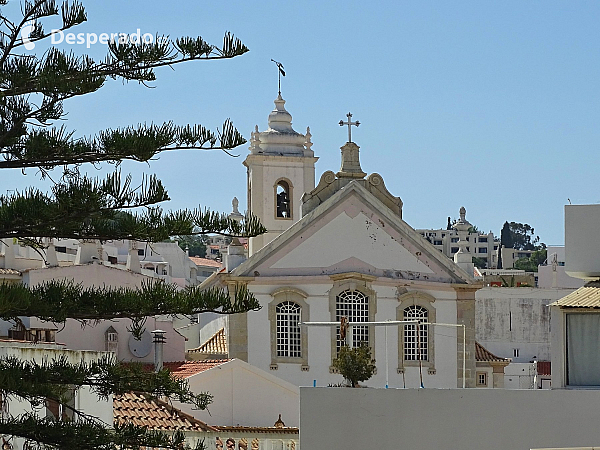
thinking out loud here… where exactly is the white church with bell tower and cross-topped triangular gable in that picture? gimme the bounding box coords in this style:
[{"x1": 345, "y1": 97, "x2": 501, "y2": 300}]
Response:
[{"x1": 202, "y1": 94, "x2": 482, "y2": 388}]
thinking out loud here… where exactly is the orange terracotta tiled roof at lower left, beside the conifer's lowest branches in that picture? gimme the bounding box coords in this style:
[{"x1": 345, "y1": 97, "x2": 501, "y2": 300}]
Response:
[{"x1": 113, "y1": 393, "x2": 217, "y2": 431}]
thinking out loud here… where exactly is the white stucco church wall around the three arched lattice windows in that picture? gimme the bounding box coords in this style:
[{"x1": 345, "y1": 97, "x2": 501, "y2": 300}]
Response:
[{"x1": 247, "y1": 283, "x2": 462, "y2": 387}]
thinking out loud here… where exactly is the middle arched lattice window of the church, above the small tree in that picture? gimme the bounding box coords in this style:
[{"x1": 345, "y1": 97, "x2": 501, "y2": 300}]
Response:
[{"x1": 335, "y1": 289, "x2": 369, "y2": 351}]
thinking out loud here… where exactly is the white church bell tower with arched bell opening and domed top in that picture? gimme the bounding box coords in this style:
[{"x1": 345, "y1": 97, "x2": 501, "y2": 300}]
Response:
[{"x1": 243, "y1": 94, "x2": 318, "y2": 256}]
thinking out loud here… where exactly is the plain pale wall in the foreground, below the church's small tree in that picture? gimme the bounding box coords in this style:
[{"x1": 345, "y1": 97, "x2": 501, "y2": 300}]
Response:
[{"x1": 300, "y1": 388, "x2": 600, "y2": 450}]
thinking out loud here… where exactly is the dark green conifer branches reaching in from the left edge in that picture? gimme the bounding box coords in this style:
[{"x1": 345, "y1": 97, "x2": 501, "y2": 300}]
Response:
[{"x1": 0, "y1": 0, "x2": 266, "y2": 450}]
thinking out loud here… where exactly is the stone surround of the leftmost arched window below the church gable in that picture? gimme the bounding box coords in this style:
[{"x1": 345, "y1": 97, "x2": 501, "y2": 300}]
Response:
[{"x1": 267, "y1": 287, "x2": 310, "y2": 370}]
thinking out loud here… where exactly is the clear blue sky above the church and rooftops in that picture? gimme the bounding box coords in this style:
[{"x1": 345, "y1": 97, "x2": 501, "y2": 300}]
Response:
[{"x1": 0, "y1": 0, "x2": 600, "y2": 244}]
